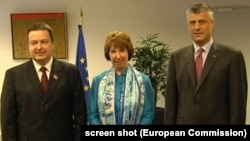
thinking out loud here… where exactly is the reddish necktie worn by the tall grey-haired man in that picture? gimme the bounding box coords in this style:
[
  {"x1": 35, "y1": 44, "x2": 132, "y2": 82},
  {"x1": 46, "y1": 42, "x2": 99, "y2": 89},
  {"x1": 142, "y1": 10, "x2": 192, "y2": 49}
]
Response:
[{"x1": 195, "y1": 47, "x2": 204, "y2": 82}]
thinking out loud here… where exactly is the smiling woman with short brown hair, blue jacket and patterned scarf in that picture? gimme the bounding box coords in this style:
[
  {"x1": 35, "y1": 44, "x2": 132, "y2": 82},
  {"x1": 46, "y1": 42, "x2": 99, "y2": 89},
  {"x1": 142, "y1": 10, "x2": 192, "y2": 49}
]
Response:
[{"x1": 88, "y1": 31, "x2": 155, "y2": 125}]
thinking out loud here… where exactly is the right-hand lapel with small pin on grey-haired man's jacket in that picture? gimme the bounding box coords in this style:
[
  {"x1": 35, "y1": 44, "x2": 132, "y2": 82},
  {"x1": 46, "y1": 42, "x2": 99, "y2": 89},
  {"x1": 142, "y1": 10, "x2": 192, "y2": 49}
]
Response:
[{"x1": 195, "y1": 44, "x2": 221, "y2": 93}]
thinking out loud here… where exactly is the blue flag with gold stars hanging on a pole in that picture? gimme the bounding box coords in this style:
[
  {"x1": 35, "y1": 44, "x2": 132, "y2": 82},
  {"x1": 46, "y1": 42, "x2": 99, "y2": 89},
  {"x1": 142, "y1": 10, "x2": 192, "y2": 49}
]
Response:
[{"x1": 76, "y1": 24, "x2": 89, "y2": 103}]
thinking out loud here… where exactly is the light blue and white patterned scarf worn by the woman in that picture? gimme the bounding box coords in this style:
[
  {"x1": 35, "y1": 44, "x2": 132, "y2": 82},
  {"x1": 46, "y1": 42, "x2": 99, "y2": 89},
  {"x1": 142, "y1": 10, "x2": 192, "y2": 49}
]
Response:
[{"x1": 98, "y1": 65, "x2": 145, "y2": 125}]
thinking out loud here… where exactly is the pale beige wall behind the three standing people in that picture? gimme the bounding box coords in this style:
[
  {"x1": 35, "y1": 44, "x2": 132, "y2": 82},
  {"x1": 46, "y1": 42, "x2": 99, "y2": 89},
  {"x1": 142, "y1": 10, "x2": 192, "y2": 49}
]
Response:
[{"x1": 0, "y1": 0, "x2": 250, "y2": 124}]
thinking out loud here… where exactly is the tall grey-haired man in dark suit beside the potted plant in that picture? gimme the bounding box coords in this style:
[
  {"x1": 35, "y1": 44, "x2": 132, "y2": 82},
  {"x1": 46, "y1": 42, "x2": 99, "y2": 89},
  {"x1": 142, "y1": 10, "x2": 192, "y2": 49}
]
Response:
[{"x1": 165, "y1": 3, "x2": 247, "y2": 124}]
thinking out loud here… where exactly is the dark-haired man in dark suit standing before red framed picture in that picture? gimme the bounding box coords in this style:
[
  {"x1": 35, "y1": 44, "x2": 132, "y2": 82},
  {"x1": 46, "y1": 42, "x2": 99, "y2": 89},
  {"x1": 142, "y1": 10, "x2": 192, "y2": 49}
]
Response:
[{"x1": 1, "y1": 23, "x2": 87, "y2": 141}]
